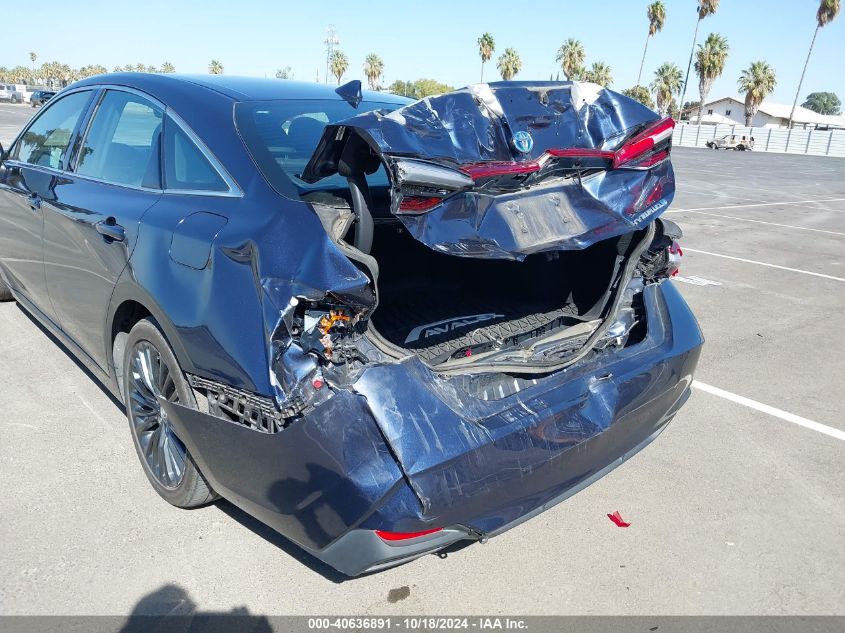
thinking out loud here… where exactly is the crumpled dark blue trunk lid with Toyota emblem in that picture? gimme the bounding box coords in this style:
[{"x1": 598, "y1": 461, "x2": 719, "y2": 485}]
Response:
[{"x1": 302, "y1": 82, "x2": 675, "y2": 260}]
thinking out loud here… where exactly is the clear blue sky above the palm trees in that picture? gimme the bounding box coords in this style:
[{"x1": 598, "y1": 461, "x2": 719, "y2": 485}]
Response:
[{"x1": 0, "y1": 0, "x2": 845, "y2": 103}]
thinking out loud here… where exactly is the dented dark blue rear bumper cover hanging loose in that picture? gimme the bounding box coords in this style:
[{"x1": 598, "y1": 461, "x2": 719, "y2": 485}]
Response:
[{"x1": 165, "y1": 282, "x2": 703, "y2": 575}]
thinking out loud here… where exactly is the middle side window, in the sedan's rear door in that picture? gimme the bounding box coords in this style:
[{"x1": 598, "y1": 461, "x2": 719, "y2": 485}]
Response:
[{"x1": 76, "y1": 90, "x2": 164, "y2": 189}]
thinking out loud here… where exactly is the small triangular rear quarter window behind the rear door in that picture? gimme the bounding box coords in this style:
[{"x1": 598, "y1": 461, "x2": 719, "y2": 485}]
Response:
[{"x1": 164, "y1": 117, "x2": 229, "y2": 191}]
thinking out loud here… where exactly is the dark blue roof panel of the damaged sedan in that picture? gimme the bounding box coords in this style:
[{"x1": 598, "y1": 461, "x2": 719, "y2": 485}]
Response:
[{"x1": 73, "y1": 73, "x2": 411, "y2": 105}]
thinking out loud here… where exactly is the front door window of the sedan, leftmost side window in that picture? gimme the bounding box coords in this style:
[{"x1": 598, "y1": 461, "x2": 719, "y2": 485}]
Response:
[{"x1": 12, "y1": 90, "x2": 91, "y2": 169}]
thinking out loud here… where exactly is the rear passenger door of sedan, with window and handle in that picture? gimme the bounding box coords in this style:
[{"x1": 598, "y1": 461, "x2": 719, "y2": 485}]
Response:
[{"x1": 44, "y1": 89, "x2": 164, "y2": 369}]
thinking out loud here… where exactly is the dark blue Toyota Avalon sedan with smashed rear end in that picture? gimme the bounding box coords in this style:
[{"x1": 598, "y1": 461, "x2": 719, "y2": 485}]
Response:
[{"x1": 0, "y1": 73, "x2": 703, "y2": 575}]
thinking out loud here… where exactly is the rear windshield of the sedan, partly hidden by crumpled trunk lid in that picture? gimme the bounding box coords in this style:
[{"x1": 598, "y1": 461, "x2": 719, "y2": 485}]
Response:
[{"x1": 235, "y1": 99, "x2": 400, "y2": 197}]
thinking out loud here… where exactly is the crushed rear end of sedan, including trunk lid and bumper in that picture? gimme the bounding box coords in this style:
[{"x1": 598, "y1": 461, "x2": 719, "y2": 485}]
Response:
[{"x1": 163, "y1": 82, "x2": 703, "y2": 575}]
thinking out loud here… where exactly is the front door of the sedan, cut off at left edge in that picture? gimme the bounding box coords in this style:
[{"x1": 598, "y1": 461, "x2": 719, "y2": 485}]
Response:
[{"x1": 0, "y1": 90, "x2": 93, "y2": 320}]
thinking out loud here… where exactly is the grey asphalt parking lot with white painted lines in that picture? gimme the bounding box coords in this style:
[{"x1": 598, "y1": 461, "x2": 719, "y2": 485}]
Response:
[{"x1": 0, "y1": 105, "x2": 845, "y2": 615}]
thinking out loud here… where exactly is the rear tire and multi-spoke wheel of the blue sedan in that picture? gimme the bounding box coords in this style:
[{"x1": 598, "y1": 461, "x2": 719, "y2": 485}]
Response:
[{"x1": 122, "y1": 318, "x2": 216, "y2": 508}]
